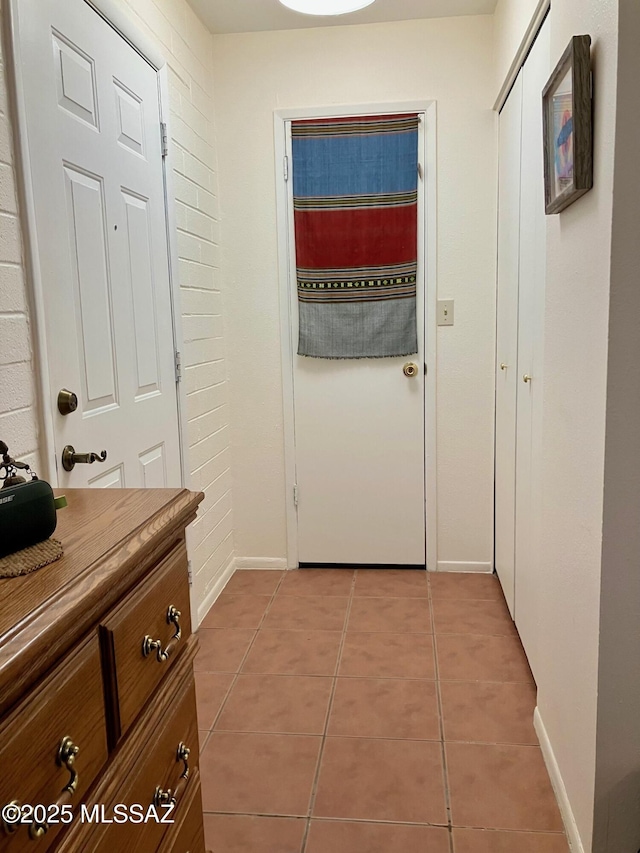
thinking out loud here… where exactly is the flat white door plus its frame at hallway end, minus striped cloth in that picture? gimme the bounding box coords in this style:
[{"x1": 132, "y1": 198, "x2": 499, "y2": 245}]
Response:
[{"x1": 275, "y1": 102, "x2": 437, "y2": 568}]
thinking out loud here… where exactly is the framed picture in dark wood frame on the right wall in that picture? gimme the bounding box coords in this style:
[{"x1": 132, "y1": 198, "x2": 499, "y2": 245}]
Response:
[{"x1": 542, "y1": 36, "x2": 593, "y2": 214}]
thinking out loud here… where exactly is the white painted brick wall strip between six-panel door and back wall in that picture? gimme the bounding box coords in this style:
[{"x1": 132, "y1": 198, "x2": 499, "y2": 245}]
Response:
[{"x1": 120, "y1": 0, "x2": 233, "y2": 615}]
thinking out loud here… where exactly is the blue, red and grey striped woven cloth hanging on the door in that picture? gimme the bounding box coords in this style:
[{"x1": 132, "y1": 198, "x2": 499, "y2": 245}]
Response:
[{"x1": 291, "y1": 114, "x2": 418, "y2": 358}]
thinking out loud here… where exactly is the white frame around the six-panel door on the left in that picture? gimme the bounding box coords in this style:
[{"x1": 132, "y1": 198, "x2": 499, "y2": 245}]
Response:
[{"x1": 2, "y1": 0, "x2": 189, "y2": 487}]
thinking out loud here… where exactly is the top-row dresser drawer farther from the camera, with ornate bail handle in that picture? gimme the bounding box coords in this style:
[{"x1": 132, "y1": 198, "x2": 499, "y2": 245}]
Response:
[{"x1": 100, "y1": 541, "x2": 191, "y2": 747}]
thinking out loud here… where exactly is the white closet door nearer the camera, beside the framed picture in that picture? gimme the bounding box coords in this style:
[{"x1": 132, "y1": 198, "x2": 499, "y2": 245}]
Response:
[{"x1": 515, "y1": 16, "x2": 550, "y2": 676}]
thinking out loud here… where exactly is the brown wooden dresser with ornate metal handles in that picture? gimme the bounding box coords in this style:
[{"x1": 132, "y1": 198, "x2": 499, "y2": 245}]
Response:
[{"x1": 0, "y1": 489, "x2": 205, "y2": 853}]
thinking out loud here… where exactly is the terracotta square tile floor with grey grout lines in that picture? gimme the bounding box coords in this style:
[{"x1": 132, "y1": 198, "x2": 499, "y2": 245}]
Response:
[{"x1": 196, "y1": 569, "x2": 568, "y2": 853}]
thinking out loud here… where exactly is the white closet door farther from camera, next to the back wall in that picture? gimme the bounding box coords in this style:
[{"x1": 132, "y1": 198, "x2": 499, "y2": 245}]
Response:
[{"x1": 495, "y1": 72, "x2": 522, "y2": 616}]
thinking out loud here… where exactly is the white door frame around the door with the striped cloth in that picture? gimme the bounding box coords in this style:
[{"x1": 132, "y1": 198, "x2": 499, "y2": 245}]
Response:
[{"x1": 273, "y1": 101, "x2": 438, "y2": 571}]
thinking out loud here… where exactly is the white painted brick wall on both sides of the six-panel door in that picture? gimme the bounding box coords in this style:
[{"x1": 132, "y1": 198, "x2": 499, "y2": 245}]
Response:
[{"x1": 0, "y1": 0, "x2": 233, "y2": 620}]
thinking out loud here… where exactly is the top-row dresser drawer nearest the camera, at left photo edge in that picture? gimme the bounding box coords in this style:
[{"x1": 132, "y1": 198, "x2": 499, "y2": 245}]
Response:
[{"x1": 0, "y1": 634, "x2": 107, "y2": 853}]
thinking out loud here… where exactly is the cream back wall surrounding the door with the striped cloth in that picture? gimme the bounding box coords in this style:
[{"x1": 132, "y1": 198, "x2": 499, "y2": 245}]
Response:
[{"x1": 213, "y1": 16, "x2": 496, "y2": 567}]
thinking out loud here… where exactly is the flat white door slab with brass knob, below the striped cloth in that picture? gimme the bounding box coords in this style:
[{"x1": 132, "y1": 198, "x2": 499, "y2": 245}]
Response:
[{"x1": 289, "y1": 115, "x2": 426, "y2": 566}]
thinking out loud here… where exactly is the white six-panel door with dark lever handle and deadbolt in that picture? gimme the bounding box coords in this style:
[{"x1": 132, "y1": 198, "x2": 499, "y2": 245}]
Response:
[{"x1": 17, "y1": 0, "x2": 181, "y2": 487}]
